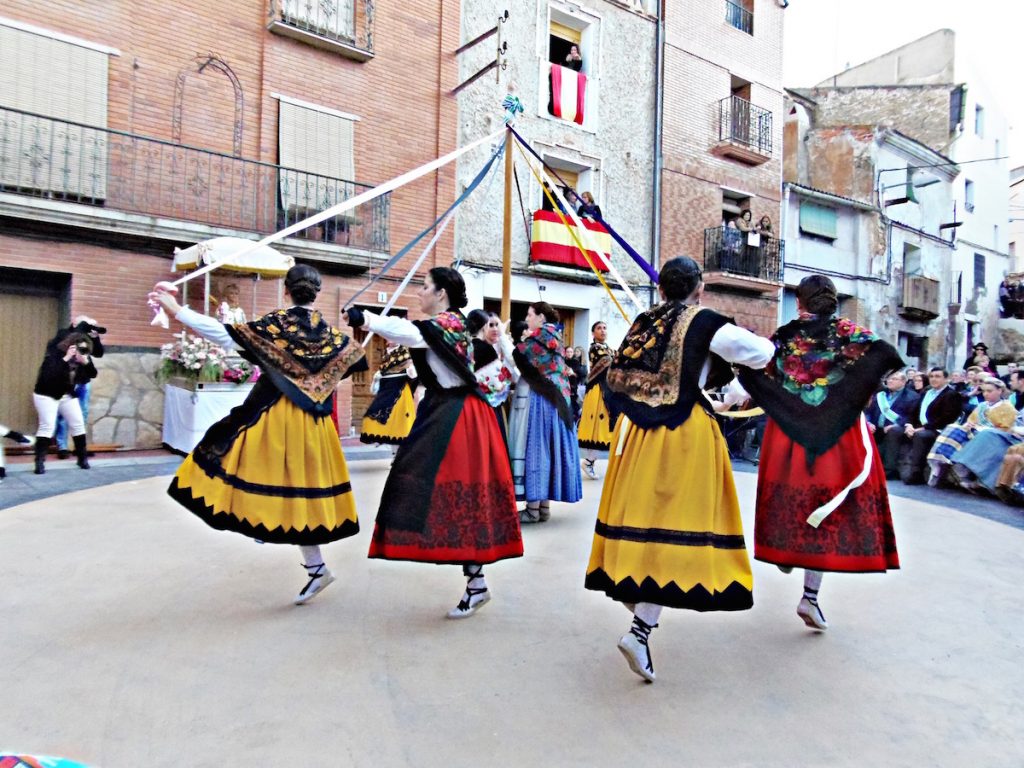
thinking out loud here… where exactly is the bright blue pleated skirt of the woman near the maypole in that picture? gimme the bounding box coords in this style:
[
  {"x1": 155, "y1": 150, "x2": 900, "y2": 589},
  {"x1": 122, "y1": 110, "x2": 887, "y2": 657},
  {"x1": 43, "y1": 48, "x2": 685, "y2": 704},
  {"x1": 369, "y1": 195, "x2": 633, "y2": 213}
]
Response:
[{"x1": 524, "y1": 392, "x2": 583, "y2": 502}]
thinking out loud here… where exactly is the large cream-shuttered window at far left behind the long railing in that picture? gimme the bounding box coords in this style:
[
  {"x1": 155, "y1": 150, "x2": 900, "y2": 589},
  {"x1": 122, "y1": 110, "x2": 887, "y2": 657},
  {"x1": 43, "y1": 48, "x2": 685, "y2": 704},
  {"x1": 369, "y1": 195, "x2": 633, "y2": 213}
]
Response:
[{"x1": 0, "y1": 25, "x2": 109, "y2": 200}]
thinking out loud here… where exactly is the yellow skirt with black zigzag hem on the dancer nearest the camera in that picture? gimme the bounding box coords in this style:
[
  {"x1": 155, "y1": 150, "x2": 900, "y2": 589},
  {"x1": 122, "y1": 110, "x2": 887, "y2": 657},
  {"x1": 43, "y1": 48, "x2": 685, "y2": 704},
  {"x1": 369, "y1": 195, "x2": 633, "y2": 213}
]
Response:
[{"x1": 586, "y1": 406, "x2": 754, "y2": 610}]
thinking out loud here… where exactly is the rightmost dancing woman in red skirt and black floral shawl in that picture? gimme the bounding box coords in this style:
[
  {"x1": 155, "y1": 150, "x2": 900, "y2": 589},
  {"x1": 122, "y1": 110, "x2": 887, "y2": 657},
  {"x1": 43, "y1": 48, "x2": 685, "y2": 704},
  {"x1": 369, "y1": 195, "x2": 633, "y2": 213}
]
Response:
[{"x1": 740, "y1": 274, "x2": 903, "y2": 631}]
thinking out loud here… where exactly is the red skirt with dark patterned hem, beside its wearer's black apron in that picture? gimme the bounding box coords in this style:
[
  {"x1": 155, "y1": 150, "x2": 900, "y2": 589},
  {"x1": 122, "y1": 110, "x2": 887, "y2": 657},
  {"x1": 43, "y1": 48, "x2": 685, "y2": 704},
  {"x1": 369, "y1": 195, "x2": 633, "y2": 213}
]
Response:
[{"x1": 370, "y1": 397, "x2": 522, "y2": 564}]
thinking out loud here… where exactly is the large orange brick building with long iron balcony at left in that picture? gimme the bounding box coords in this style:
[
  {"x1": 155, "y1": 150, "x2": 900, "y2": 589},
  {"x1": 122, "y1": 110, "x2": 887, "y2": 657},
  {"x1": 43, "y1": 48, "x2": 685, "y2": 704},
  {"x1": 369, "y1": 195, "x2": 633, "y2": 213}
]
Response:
[{"x1": 0, "y1": 0, "x2": 460, "y2": 447}]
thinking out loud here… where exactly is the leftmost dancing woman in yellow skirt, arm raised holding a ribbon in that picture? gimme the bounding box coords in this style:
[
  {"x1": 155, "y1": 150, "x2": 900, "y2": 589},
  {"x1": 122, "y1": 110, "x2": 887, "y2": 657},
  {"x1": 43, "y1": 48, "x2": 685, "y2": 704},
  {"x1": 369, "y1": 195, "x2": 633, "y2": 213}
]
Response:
[{"x1": 150, "y1": 264, "x2": 367, "y2": 604}]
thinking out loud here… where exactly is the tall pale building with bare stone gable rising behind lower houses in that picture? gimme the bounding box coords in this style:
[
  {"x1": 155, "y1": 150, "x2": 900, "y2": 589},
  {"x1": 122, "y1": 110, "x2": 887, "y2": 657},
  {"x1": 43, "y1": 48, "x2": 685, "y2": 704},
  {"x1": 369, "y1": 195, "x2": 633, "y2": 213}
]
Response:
[{"x1": 798, "y1": 30, "x2": 1013, "y2": 360}]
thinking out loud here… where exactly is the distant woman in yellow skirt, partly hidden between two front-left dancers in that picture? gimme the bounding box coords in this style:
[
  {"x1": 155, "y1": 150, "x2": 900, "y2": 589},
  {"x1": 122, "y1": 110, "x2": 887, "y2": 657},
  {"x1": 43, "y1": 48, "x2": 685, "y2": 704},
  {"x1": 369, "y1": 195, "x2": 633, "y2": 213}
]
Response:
[{"x1": 359, "y1": 344, "x2": 417, "y2": 456}]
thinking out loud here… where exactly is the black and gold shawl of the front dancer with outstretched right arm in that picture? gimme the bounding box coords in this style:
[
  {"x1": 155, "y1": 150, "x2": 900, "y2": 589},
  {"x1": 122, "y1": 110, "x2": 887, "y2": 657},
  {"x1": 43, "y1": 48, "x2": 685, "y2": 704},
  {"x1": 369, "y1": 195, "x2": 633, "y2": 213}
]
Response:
[{"x1": 605, "y1": 301, "x2": 732, "y2": 429}]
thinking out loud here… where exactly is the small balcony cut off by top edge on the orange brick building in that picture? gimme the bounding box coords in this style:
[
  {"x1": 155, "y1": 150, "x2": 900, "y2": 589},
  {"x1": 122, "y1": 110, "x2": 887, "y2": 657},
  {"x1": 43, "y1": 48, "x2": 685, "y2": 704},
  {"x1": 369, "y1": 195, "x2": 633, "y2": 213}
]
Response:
[{"x1": 267, "y1": 0, "x2": 375, "y2": 61}]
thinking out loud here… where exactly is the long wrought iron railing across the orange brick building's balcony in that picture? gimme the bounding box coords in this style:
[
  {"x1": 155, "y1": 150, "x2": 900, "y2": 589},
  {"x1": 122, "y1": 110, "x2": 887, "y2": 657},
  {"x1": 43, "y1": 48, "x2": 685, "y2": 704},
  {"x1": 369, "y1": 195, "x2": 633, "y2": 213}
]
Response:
[{"x1": 0, "y1": 108, "x2": 390, "y2": 252}]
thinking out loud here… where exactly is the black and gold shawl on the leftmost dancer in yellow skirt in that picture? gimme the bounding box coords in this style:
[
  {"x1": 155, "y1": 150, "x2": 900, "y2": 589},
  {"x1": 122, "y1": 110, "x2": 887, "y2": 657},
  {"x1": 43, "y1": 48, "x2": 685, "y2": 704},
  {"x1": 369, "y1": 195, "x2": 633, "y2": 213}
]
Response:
[{"x1": 225, "y1": 307, "x2": 367, "y2": 417}]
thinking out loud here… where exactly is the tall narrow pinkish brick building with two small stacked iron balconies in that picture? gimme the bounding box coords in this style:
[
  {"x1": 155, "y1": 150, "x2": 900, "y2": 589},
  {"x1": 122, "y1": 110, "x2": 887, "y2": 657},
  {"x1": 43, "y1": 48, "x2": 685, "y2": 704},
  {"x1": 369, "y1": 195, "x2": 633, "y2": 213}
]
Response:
[{"x1": 659, "y1": 0, "x2": 783, "y2": 333}]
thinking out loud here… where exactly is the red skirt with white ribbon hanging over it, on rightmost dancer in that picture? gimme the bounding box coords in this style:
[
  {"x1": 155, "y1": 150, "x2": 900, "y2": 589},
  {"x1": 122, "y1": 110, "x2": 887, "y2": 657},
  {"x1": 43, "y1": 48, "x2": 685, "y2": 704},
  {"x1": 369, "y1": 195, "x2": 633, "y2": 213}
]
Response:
[{"x1": 754, "y1": 419, "x2": 899, "y2": 572}]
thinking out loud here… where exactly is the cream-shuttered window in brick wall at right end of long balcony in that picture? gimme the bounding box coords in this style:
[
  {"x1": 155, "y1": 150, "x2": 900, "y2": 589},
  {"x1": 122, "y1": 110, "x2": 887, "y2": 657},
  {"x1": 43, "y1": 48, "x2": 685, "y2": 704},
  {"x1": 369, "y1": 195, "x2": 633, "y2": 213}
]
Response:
[{"x1": 278, "y1": 98, "x2": 355, "y2": 218}]
